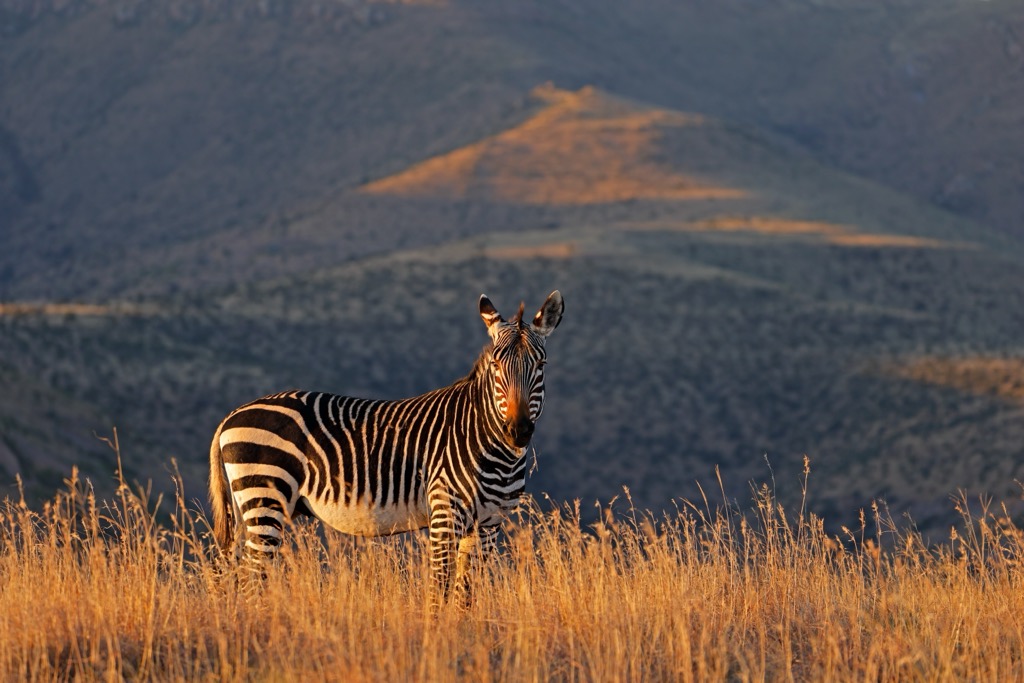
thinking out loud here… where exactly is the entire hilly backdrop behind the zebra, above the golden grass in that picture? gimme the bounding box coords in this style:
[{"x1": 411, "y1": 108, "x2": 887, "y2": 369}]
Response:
[{"x1": 0, "y1": 0, "x2": 1024, "y2": 536}]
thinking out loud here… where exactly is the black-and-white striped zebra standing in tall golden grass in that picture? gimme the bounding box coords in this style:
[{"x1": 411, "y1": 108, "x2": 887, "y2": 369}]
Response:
[{"x1": 209, "y1": 290, "x2": 564, "y2": 608}]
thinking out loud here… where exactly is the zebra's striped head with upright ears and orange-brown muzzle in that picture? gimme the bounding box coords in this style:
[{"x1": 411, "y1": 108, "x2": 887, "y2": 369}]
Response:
[{"x1": 480, "y1": 290, "x2": 564, "y2": 449}]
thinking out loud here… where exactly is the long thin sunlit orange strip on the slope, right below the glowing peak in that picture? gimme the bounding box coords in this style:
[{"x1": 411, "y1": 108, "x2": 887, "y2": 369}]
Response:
[{"x1": 622, "y1": 216, "x2": 973, "y2": 249}]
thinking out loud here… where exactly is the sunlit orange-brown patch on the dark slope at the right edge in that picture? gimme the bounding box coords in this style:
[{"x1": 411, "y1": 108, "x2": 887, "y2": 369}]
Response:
[{"x1": 889, "y1": 355, "x2": 1024, "y2": 402}]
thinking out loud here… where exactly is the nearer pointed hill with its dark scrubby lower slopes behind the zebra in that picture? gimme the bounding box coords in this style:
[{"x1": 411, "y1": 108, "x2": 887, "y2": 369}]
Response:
[{"x1": 0, "y1": 89, "x2": 1024, "y2": 535}]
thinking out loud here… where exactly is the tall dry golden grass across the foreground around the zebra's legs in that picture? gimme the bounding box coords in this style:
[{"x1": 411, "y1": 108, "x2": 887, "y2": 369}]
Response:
[{"x1": 0, "y1": 454, "x2": 1024, "y2": 681}]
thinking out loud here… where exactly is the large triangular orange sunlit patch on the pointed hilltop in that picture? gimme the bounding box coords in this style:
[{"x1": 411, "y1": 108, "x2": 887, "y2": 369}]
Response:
[{"x1": 361, "y1": 86, "x2": 744, "y2": 206}]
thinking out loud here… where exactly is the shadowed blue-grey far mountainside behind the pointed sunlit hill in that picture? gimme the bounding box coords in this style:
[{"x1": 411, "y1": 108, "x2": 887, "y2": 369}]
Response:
[{"x1": 0, "y1": 0, "x2": 1024, "y2": 301}]
